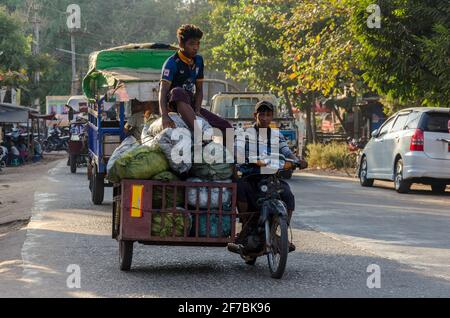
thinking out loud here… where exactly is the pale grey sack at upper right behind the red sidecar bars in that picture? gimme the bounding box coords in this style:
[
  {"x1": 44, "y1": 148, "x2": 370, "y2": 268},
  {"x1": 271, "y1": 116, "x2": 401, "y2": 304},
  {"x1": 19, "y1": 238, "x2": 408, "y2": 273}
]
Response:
[{"x1": 186, "y1": 178, "x2": 232, "y2": 209}]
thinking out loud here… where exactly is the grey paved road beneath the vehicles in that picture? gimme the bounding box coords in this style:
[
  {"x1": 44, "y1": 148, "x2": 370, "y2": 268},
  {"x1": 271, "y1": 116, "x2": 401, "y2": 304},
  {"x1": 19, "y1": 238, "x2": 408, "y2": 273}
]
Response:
[{"x1": 0, "y1": 162, "x2": 450, "y2": 297}]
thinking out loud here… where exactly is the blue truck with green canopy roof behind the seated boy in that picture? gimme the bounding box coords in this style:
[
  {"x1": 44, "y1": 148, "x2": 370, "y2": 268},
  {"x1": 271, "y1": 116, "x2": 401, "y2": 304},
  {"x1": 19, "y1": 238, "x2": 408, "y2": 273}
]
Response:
[{"x1": 83, "y1": 43, "x2": 177, "y2": 205}]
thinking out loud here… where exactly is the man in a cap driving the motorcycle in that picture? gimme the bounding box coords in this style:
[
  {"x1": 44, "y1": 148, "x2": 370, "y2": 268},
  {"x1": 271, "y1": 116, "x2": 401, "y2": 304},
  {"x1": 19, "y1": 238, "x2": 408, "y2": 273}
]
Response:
[{"x1": 235, "y1": 101, "x2": 300, "y2": 252}]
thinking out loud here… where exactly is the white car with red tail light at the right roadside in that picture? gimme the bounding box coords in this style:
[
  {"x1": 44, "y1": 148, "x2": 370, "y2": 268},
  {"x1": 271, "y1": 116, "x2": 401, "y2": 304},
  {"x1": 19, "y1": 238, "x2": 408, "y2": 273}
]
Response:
[{"x1": 359, "y1": 108, "x2": 450, "y2": 193}]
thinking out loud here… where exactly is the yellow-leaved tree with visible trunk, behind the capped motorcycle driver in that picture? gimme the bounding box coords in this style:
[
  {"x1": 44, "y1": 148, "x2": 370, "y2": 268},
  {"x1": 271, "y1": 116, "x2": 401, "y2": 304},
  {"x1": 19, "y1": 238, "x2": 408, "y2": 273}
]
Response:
[{"x1": 277, "y1": 0, "x2": 364, "y2": 141}]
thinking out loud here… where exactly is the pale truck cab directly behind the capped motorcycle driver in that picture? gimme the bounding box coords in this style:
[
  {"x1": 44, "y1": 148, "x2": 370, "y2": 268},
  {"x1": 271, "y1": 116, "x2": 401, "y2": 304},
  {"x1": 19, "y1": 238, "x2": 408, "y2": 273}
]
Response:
[{"x1": 211, "y1": 92, "x2": 299, "y2": 153}]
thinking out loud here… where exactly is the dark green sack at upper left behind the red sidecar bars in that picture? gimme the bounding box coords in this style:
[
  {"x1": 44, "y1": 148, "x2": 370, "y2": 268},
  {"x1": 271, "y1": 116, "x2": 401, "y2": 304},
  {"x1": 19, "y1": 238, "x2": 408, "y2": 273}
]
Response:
[{"x1": 152, "y1": 171, "x2": 184, "y2": 209}]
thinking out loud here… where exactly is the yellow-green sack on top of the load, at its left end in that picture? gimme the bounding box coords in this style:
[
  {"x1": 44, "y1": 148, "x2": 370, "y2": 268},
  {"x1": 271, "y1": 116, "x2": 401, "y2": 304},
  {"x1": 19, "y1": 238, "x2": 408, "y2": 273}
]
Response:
[{"x1": 110, "y1": 145, "x2": 169, "y2": 182}]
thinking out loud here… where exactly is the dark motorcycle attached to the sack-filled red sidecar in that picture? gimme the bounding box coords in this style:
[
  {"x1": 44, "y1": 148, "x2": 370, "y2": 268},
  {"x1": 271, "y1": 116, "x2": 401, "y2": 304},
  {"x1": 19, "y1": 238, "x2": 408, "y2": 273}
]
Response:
[{"x1": 228, "y1": 155, "x2": 306, "y2": 279}]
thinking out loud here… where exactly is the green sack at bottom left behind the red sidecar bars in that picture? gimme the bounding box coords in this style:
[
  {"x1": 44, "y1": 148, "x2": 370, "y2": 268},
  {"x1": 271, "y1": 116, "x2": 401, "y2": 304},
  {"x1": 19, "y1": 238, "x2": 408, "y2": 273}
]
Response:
[{"x1": 151, "y1": 212, "x2": 192, "y2": 237}]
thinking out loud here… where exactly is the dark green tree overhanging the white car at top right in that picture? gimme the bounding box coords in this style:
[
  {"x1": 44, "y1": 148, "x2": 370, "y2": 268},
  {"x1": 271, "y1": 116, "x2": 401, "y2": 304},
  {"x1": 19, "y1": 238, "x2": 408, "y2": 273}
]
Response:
[{"x1": 351, "y1": 0, "x2": 450, "y2": 106}]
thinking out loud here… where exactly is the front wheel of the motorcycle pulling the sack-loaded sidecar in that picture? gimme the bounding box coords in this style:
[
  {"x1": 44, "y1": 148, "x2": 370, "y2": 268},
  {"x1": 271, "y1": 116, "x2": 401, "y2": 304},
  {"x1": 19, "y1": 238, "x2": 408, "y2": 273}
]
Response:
[{"x1": 266, "y1": 215, "x2": 289, "y2": 279}]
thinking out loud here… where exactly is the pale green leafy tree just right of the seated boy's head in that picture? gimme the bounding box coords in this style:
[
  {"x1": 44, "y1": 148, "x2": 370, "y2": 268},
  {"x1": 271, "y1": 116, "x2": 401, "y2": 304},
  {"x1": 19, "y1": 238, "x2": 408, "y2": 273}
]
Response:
[{"x1": 212, "y1": 0, "x2": 293, "y2": 92}]
